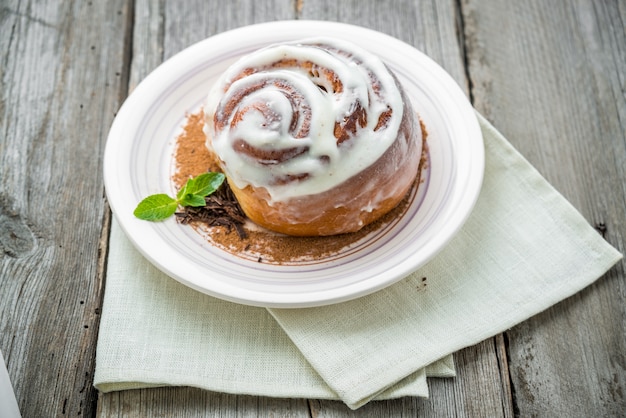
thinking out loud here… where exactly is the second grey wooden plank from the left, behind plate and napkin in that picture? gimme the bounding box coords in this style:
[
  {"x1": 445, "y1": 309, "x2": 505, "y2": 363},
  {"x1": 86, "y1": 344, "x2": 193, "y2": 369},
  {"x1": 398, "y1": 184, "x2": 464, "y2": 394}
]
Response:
[{"x1": 97, "y1": 0, "x2": 309, "y2": 417}]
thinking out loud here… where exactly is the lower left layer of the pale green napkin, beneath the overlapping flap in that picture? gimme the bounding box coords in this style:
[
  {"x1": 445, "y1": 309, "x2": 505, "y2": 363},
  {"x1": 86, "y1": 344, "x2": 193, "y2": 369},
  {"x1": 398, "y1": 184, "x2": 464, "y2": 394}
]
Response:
[{"x1": 94, "y1": 220, "x2": 454, "y2": 399}]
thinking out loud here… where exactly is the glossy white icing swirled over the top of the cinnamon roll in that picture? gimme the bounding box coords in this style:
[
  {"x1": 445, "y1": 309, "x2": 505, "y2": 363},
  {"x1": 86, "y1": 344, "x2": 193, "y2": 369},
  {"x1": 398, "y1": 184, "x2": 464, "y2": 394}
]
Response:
[{"x1": 204, "y1": 38, "x2": 414, "y2": 205}]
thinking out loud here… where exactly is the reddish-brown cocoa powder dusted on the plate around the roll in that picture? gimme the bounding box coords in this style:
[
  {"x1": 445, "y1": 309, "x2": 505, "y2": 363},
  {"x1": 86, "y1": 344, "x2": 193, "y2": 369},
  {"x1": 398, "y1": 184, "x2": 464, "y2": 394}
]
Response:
[{"x1": 172, "y1": 111, "x2": 427, "y2": 264}]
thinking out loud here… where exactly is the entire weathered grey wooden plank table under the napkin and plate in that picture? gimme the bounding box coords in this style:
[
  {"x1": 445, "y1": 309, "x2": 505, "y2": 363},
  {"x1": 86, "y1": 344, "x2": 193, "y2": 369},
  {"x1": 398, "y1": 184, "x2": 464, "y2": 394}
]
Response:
[{"x1": 0, "y1": 0, "x2": 626, "y2": 417}]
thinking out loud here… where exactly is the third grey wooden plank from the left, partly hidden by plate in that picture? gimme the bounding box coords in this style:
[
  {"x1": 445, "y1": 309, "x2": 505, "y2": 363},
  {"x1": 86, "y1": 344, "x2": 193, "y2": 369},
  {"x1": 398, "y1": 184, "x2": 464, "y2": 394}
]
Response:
[{"x1": 301, "y1": 0, "x2": 513, "y2": 417}]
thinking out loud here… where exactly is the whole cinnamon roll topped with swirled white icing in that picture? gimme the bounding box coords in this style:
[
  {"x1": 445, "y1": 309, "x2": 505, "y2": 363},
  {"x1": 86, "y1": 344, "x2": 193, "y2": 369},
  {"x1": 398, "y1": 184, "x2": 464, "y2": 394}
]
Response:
[{"x1": 204, "y1": 38, "x2": 422, "y2": 236}]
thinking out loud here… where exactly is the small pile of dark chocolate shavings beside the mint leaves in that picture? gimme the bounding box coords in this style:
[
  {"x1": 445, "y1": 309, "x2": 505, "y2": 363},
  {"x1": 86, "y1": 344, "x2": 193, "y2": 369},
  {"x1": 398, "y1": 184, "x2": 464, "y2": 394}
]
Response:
[{"x1": 176, "y1": 182, "x2": 248, "y2": 239}]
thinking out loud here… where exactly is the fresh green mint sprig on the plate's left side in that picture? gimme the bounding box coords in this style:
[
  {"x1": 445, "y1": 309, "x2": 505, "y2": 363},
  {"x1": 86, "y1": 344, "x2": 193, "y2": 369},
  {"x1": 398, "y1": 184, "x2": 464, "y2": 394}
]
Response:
[{"x1": 133, "y1": 172, "x2": 225, "y2": 221}]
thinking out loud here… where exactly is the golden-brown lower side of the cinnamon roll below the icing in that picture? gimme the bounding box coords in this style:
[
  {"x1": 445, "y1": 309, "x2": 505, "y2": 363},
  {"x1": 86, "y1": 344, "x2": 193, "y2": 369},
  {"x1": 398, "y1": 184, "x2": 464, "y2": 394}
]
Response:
[{"x1": 229, "y1": 90, "x2": 426, "y2": 236}]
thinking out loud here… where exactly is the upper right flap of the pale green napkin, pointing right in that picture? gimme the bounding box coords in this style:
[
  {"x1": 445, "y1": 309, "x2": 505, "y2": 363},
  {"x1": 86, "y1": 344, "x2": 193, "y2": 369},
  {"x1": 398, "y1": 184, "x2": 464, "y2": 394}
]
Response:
[{"x1": 270, "y1": 115, "x2": 621, "y2": 408}]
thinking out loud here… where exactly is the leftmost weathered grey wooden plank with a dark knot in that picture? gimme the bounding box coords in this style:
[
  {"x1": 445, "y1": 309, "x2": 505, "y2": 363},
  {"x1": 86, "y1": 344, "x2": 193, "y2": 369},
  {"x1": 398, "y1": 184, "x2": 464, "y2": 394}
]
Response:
[{"x1": 0, "y1": 0, "x2": 129, "y2": 417}]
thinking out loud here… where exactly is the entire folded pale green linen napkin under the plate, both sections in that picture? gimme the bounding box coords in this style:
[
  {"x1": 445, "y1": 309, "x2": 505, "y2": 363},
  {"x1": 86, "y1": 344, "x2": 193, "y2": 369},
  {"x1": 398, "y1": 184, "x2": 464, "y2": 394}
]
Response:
[{"x1": 94, "y1": 116, "x2": 621, "y2": 408}]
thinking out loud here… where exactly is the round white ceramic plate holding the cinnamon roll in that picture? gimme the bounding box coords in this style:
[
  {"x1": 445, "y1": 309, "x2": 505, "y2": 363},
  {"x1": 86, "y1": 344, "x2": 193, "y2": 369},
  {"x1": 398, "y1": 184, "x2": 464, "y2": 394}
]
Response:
[{"x1": 104, "y1": 21, "x2": 484, "y2": 307}]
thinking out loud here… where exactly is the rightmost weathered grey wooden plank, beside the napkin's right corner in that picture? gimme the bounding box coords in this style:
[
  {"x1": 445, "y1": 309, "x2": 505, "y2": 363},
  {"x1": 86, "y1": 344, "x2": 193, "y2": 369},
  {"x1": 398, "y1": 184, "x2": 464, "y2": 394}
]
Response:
[{"x1": 462, "y1": 0, "x2": 626, "y2": 416}]
